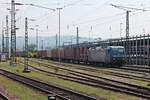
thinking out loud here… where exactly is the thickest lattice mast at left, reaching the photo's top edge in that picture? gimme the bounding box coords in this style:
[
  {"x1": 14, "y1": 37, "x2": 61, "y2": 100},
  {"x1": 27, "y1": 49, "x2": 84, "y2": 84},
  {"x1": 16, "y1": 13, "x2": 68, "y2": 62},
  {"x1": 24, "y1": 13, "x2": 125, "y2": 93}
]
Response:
[{"x1": 10, "y1": 0, "x2": 16, "y2": 66}]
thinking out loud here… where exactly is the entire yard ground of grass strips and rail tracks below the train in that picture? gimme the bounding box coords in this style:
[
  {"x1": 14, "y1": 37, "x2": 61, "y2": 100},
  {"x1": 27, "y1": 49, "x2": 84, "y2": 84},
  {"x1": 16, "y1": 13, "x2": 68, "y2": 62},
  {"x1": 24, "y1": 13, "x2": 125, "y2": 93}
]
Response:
[{"x1": 0, "y1": 58, "x2": 150, "y2": 100}]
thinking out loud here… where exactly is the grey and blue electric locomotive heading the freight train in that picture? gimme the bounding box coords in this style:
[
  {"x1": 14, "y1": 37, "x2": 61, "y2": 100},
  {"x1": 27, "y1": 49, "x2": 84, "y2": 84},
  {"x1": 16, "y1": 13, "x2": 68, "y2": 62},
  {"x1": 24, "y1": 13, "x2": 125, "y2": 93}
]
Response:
[{"x1": 88, "y1": 46, "x2": 125, "y2": 65}]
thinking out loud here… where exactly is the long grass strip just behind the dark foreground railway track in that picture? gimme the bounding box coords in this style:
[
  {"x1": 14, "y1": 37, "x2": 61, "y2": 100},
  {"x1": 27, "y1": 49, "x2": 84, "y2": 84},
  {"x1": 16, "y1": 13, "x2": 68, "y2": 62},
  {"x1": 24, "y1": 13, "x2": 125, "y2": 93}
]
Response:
[{"x1": 0, "y1": 63, "x2": 140, "y2": 100}]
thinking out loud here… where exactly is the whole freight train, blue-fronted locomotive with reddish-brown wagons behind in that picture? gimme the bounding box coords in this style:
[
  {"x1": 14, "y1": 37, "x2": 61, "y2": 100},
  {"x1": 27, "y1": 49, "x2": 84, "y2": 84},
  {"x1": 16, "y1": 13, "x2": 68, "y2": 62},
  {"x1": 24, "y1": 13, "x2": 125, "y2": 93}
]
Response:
[{"x1": 37, "y1": 45, "x2": 125, "y2": 65}]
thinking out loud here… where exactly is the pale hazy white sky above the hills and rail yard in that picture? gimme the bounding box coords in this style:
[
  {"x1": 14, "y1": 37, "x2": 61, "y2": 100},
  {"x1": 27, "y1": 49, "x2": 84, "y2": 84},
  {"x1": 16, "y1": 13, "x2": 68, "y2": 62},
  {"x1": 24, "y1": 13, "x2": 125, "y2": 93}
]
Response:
[{"x1": 0, "y1": 0, "x2": 150, "y2": 39}]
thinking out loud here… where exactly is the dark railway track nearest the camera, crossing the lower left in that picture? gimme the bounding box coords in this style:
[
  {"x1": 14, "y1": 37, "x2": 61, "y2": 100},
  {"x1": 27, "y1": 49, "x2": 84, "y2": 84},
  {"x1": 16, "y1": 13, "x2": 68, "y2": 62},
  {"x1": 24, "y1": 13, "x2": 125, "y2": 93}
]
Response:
[{"x1": 0, "y1": 69, "x2": 96, "y2": 100}]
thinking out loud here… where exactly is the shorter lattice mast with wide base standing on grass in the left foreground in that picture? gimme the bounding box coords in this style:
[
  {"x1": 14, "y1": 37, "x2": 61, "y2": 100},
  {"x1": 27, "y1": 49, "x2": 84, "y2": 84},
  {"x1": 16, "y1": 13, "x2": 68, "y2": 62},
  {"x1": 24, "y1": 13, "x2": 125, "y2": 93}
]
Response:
[{"x1": 23, "y1": 17, "x2": 30, "y2": 72}]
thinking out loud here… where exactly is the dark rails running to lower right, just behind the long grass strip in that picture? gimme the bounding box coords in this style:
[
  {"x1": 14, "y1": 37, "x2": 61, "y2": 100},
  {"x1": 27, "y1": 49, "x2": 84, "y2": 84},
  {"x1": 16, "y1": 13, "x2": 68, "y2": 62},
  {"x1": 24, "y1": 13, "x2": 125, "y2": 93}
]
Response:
[{"x1": 23, "y1": 59, "x2": 150, "y2": 99}]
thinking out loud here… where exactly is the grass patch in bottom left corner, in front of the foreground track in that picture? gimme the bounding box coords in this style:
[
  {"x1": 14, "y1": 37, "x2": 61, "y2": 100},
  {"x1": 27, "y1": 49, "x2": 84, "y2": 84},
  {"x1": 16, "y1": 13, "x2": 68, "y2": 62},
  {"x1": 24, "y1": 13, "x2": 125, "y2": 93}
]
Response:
[{"x1": 0, "y1": 76, "x2": 47, "y2": 100}]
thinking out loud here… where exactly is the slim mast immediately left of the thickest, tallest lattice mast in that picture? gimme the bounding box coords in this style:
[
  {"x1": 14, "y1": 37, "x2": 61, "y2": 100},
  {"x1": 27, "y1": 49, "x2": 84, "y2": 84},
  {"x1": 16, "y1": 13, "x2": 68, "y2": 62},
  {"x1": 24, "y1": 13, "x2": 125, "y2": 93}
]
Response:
[{"x1": 5, "y1": 15, "x2": 9, "y2": 59}]
